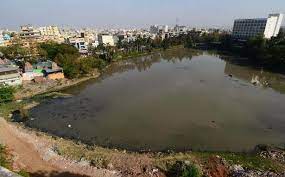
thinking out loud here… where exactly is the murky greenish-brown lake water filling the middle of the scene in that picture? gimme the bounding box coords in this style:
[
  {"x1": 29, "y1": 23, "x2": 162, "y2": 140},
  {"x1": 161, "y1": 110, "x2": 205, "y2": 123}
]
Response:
[{"x1": 27, "y1": 49, "x2": 285, "y2": 151}]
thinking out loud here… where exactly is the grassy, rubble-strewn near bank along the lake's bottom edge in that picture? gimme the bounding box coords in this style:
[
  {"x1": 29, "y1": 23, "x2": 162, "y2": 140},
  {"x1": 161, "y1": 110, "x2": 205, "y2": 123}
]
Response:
[{"x1": 0, "y1": 118, "x2": 285, "y2": 177}]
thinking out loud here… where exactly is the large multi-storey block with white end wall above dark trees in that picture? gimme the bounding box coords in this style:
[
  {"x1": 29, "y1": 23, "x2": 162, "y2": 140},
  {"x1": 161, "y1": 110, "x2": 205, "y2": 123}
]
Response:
[{"x1": 232, "y1": 14, "x2": 283, "y2": 39}]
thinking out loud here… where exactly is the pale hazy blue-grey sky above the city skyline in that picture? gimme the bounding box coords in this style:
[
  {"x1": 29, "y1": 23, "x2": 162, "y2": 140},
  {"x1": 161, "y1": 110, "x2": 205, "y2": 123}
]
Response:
[{"x1": 0, "y1": 0, "x2": 285, "y2": 29}]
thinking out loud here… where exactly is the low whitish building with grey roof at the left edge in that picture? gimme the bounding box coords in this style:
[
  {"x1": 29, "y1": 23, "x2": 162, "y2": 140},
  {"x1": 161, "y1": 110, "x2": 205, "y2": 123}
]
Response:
[{"x1": 0, "y1": 65, "x2": 22, "y2": 86}]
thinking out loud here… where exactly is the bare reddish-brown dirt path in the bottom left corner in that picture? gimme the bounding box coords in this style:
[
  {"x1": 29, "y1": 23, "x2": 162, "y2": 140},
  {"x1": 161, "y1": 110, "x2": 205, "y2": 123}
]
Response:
[{"x1": 0, "y1": 118, "x2": 119, "y2": 177}]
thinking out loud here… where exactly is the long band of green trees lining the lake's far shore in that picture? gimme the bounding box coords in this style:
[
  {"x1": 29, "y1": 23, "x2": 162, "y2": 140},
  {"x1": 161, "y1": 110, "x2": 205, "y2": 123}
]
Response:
[{"x1": 0, "y1": 30, "x2": 285, "y2": 78}]
